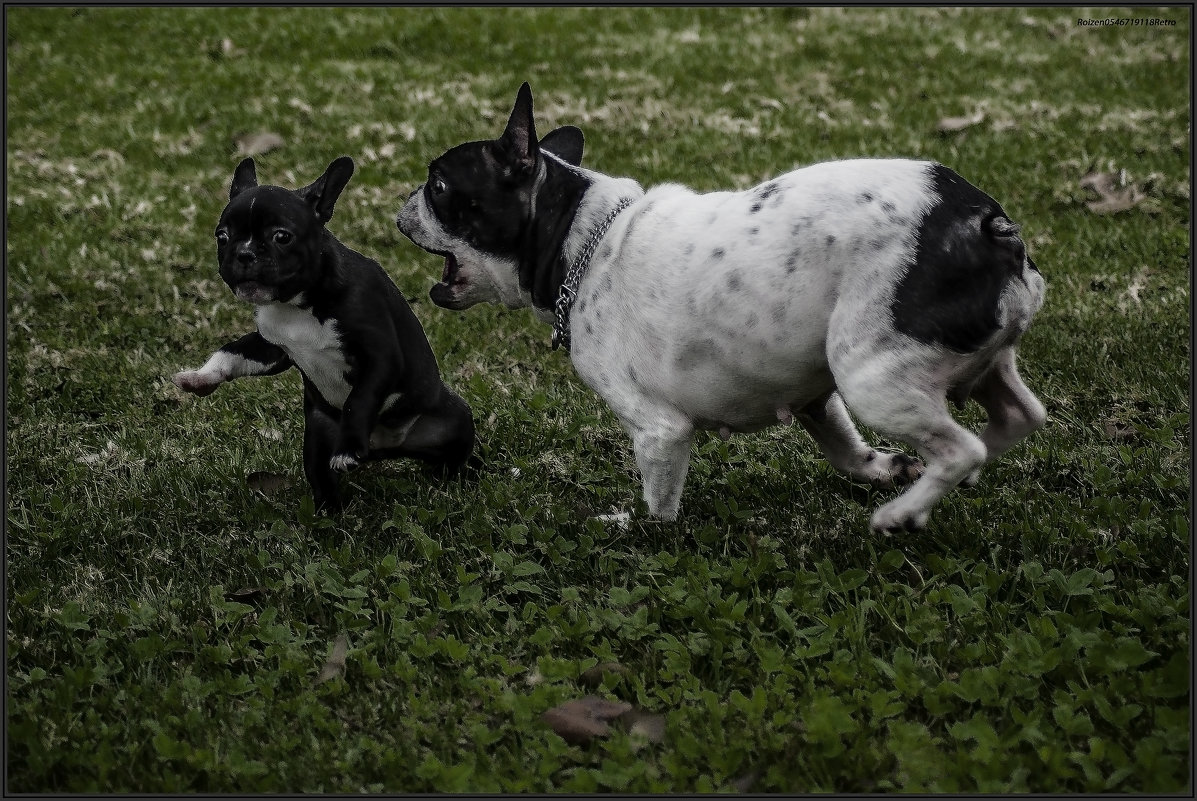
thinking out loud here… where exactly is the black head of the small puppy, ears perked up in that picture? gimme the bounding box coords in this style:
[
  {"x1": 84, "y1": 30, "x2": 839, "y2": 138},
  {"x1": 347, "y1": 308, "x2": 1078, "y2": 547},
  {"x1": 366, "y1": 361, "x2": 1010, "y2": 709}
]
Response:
[{"x1": 215, "y1": 158, "x2": 353, "y2": 304}]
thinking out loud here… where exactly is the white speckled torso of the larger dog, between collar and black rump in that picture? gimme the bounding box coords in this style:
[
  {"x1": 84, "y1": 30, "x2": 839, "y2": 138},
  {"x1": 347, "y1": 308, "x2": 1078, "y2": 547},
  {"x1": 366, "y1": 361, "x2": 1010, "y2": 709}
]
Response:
[{"x1": 571, "y1": 160, "x2": 926, "y2": 431}]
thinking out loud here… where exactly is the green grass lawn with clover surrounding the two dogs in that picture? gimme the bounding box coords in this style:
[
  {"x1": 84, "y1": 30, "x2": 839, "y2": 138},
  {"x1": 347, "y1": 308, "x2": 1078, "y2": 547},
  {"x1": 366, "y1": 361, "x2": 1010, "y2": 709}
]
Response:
[{"x1": 5, "y1": 7, "x2": 1192, "y2": 794}]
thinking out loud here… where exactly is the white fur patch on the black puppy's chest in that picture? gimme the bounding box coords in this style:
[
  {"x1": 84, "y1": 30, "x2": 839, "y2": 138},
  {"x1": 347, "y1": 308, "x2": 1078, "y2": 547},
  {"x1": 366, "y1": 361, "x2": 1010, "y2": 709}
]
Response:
[{"x1": 254, "y1": 303, "x2": 351, "y2": 408}]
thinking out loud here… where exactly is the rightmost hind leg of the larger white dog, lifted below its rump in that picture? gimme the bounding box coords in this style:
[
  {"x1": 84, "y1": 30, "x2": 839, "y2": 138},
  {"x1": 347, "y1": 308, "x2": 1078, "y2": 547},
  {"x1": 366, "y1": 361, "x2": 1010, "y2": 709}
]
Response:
[{"x1": 964, "y1": 347, "x2": 1047, "y2": 486}]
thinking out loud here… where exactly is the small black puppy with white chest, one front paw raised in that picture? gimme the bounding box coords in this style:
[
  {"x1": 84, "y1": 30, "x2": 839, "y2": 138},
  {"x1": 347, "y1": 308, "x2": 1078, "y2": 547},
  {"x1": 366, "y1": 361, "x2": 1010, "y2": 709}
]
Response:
[{"x1": 174, "y1": 157, "x2": 474, "y2": 510}]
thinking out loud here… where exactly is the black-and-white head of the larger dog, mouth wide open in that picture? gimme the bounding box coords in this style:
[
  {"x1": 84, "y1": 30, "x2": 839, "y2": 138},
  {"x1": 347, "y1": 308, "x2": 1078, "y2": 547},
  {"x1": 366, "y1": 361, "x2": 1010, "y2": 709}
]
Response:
[{"x1": 395, "y1": 84, "x2": 583, "y2": 310}]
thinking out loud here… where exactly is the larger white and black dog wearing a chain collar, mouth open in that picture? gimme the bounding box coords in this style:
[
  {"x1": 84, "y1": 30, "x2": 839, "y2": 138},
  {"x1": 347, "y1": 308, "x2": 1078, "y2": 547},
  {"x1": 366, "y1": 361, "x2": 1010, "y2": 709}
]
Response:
[{"x1": 396, "y1": 84, "x2": 1045, "y2": 532}]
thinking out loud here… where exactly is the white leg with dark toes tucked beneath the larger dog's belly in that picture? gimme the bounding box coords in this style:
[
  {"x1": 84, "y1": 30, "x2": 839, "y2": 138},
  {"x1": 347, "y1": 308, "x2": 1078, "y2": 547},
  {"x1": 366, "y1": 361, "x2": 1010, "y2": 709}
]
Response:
[{"x1": 796, "y1": 392, "x2": 923, "y2": 489}]
